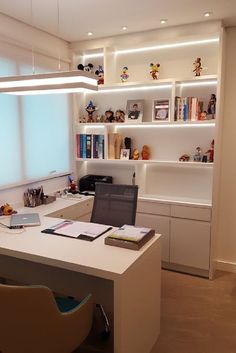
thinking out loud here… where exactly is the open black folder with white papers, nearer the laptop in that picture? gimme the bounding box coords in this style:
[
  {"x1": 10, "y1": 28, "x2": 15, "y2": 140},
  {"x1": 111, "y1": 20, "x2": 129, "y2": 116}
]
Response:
[{"x1": 42, "y1": 220, "x2": 112, "y2": 241}]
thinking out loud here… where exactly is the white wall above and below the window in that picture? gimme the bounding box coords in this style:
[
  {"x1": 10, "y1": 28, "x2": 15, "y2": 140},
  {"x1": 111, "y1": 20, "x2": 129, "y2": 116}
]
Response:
[{"x1": 0, "y1": 14, "x2": 70, "y2": 206}]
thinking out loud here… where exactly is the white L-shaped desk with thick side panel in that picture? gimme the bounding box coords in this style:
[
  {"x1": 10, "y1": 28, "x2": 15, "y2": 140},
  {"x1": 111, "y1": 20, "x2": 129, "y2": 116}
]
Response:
[{"x1": 0, "y1": 199, "x2": 161, "y2": 353}]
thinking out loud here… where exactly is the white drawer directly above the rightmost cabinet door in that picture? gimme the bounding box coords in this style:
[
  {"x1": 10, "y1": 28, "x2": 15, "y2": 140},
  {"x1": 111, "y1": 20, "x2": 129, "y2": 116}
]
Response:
[{"x1": 171, "y1": 205, "x2": 211, "y2": 222}]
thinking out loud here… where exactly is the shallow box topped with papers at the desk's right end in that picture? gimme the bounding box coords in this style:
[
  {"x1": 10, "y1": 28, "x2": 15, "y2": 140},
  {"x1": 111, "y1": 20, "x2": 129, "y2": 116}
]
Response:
[{"x1": 104, "y1": 224, "x2": 155, "y2": 250}]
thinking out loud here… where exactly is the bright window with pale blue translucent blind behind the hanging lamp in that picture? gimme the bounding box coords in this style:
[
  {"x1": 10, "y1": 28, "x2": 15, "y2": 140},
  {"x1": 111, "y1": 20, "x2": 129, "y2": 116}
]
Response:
[{"x1": 0, "y1": 51, "x2": 71, "y2": 188}]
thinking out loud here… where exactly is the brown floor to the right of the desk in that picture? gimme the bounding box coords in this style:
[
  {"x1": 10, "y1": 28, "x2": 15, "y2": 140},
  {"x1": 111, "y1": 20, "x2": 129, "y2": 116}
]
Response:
[{"x1": 152, "y1": 271, "x2": 236, "y2": 353}]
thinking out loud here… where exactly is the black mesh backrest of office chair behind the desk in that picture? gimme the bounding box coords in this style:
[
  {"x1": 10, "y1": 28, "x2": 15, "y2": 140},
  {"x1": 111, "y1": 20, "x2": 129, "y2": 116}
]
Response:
[{"x1": 90, "y1": 183, "x2": 138, "y2": 227}]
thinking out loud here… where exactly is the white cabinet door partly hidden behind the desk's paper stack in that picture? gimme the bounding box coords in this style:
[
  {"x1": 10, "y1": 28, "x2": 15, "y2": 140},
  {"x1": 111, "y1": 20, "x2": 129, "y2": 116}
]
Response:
[{"x1": 135, "y1": 213, "x2": 170, "y2": 262}]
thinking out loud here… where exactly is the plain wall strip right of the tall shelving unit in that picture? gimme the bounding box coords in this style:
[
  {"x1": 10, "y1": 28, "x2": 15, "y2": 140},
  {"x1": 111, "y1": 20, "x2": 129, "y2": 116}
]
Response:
[{"x1": 217, "y1": 27, "x2": 236, "y2": 271}]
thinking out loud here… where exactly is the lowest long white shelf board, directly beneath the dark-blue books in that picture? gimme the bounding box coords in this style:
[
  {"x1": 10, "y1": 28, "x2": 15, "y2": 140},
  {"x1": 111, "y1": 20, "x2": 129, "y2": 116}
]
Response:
[{"x1": 76, "y1": 158, "x2": 213, "y2": 168}]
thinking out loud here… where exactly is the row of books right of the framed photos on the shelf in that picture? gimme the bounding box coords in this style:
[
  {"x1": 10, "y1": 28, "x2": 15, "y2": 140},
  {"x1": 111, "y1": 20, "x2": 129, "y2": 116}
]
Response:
[{"x1": 174, "y1": 97, "x2": 203, "y2": 121}]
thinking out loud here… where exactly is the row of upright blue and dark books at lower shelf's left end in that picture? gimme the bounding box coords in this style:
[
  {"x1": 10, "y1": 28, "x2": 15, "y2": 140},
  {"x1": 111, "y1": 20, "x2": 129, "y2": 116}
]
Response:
[{"x1": 76, "y1": 134, "x2": 104, "y2": 159}]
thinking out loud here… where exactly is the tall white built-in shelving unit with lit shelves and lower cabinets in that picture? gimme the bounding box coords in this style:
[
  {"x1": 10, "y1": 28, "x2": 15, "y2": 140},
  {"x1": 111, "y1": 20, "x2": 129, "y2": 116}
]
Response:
[{"x1": 74, "y1": 20, "x2": 221, "y2": 276}]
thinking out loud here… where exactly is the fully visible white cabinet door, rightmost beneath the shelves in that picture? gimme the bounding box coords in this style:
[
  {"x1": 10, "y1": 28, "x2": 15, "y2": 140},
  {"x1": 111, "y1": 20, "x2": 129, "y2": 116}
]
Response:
[{"x1": 170, "y1": 218, "x2": 211, "y2": 270}]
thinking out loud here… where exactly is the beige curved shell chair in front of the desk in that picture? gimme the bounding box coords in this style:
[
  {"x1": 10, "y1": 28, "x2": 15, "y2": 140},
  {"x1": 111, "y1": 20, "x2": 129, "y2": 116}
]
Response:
[{"x1": 0, "y1": 284, "x2": 93, "y2": 353}]
